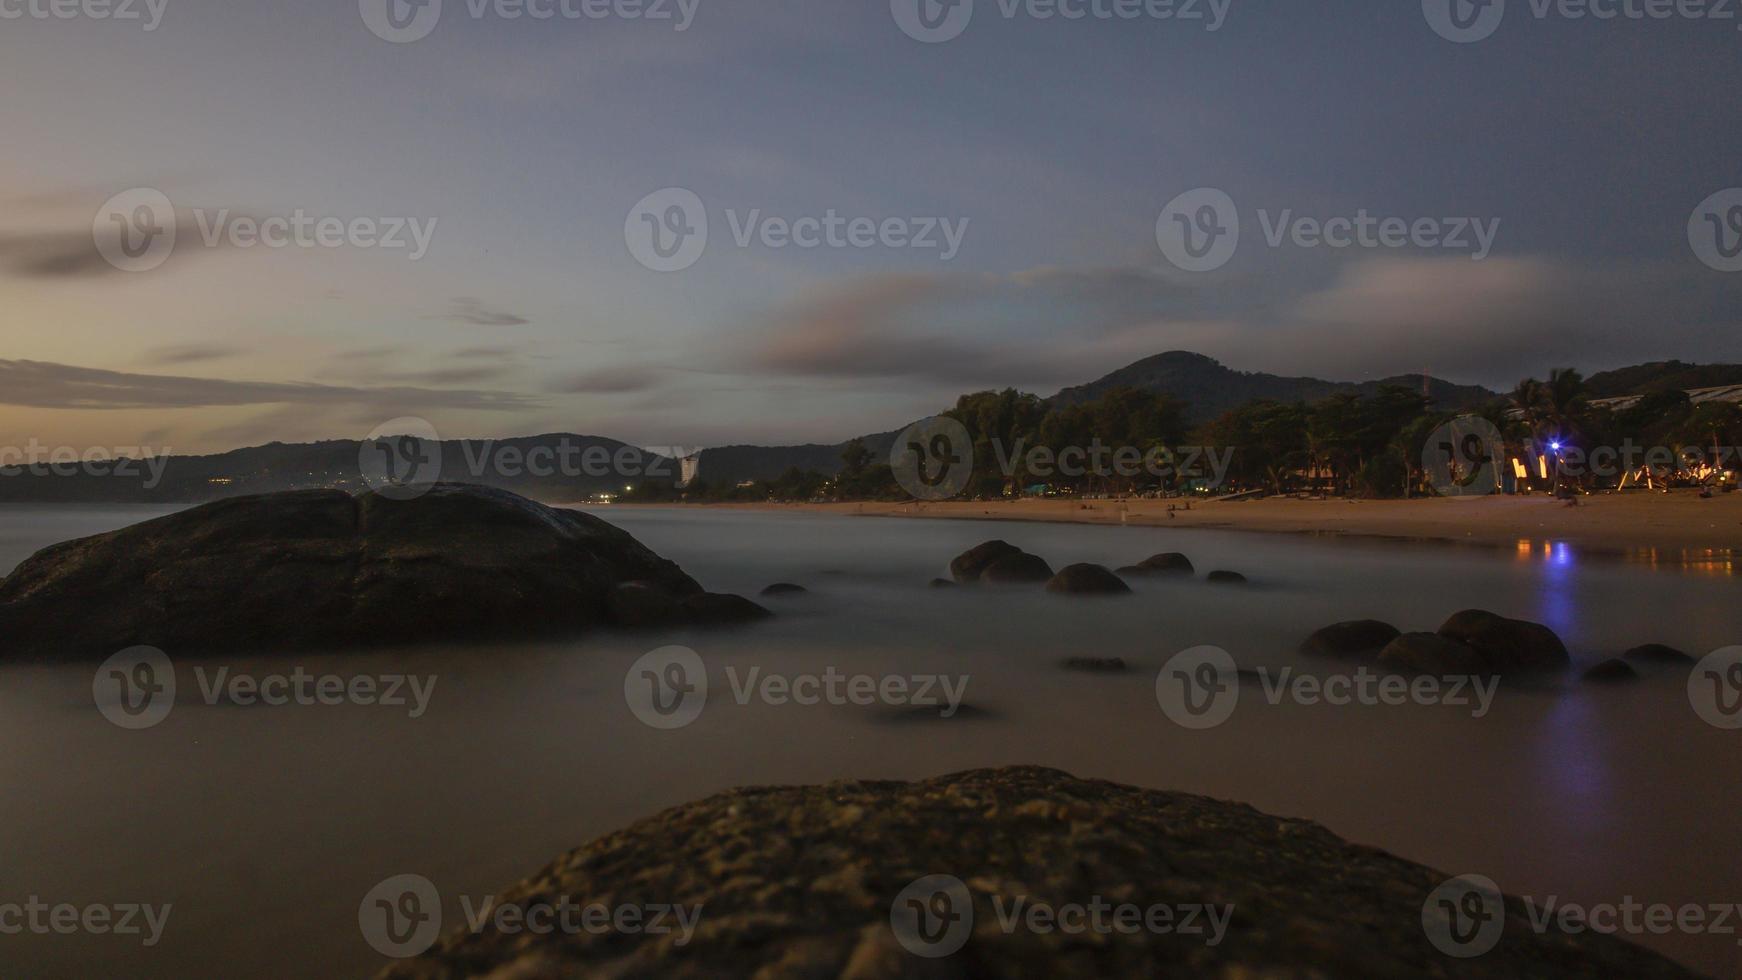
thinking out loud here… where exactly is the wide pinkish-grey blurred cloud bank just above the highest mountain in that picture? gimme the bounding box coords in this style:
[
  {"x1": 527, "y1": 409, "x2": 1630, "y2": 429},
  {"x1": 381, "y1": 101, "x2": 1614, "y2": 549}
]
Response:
[{"x1": 735, "y1": 258, "x2": 1742, "y2": 393}]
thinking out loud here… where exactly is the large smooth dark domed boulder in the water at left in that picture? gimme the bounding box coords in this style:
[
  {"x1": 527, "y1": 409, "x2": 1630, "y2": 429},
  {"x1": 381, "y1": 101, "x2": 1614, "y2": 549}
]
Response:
[{"x1": 0, "y1": 484, "x2": 766, "y2": 660}]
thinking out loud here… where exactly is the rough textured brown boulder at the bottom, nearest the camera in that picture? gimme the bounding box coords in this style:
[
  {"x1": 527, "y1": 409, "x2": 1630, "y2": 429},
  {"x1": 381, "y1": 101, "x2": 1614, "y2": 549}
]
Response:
[{"x1": 381, "y1": 768, "x2": 1693, "y2": 980}]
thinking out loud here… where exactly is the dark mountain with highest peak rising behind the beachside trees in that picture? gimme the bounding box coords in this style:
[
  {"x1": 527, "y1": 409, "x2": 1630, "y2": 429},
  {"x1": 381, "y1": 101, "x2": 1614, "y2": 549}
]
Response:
[{"x1": 1052, "y1": 350, "x2": 1498, "y2": 421}]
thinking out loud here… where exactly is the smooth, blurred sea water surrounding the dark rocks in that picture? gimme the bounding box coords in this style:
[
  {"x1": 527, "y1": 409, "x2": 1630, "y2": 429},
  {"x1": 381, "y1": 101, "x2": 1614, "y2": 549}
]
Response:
[{"x1": 0, "y1": 508, "x2": 1742, "y2": 977}]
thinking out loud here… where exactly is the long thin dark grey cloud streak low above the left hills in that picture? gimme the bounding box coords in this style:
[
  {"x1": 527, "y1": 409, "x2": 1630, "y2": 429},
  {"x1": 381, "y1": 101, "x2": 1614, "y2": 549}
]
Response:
[{"x1": 0, "y1": 360, "x2": 540, "y2": 411}]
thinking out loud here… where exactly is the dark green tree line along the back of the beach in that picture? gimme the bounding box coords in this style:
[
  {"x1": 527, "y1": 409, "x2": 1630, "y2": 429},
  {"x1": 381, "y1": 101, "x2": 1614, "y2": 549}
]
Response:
[{"x1": 625, "y1": 367, "x2": 1742, "y2": 501}]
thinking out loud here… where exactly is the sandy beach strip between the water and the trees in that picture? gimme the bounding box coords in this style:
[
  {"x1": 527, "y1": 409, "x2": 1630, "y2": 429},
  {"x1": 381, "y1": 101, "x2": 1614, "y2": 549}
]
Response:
[{"x1": 648, "y1": 491, "x2": 1742, "y2": 564}]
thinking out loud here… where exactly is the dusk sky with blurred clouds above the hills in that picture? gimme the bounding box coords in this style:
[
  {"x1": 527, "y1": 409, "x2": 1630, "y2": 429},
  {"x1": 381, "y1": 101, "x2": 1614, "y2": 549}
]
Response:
[{"x1": 0, "y1": 0, "x2": 1742, "y2": 453}]
